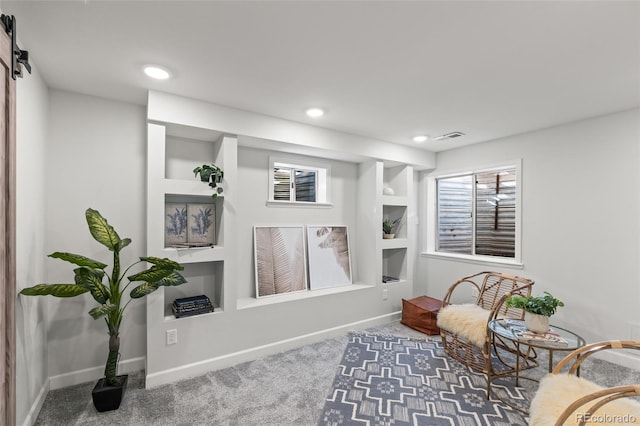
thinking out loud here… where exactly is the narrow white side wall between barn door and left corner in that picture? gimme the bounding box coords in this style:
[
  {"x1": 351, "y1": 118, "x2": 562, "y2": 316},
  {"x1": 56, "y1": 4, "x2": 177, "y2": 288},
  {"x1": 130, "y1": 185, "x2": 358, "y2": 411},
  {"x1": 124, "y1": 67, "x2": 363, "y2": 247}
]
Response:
[{"x1": 15, "y1": 66, "x2": 49, "y2": 425}]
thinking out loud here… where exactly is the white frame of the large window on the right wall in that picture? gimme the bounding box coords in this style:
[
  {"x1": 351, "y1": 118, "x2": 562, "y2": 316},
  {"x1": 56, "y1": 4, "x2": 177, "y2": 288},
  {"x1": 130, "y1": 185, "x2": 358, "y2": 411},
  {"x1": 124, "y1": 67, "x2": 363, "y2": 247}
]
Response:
[{"x1": 421, "y1": 159, "x2": 524, "y2": 269}]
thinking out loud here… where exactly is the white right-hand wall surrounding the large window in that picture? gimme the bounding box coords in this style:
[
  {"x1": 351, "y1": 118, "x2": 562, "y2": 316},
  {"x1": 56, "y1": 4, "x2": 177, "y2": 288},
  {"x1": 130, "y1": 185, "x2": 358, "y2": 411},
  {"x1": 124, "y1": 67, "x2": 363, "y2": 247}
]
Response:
[{"x1": 416, "y1": 109, "x2": 640, "y2": 362}]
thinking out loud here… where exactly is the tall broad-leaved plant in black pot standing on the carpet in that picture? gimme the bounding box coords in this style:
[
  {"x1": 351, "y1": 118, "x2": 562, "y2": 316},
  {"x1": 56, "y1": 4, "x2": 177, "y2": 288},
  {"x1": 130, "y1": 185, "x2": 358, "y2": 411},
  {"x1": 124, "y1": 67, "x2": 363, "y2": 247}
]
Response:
[{"x1": 20, "y1": 209, "x2": 186, "y2": 411}]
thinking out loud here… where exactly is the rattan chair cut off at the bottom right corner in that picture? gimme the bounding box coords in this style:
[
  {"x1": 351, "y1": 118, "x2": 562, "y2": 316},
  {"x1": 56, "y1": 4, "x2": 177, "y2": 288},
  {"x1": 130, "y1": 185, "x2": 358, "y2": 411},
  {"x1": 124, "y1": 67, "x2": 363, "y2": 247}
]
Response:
[{"x1": 529, "y1": 341, "x2": 640, "y2": 426}]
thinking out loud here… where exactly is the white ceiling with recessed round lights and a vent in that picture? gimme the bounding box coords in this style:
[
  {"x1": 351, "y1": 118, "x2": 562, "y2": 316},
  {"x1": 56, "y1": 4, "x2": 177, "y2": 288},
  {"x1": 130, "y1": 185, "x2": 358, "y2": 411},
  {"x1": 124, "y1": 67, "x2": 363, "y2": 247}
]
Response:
[{"x1": 0, "y1": 0, "x2": 640, "y2": 151}]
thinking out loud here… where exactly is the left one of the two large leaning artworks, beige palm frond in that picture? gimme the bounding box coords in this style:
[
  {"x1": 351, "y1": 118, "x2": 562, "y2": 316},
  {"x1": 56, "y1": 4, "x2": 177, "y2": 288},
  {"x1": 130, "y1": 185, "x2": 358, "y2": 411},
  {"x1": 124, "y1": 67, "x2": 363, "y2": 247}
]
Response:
[{"x1": 253, "y1": 226, "x2": 307, "y2": 297}]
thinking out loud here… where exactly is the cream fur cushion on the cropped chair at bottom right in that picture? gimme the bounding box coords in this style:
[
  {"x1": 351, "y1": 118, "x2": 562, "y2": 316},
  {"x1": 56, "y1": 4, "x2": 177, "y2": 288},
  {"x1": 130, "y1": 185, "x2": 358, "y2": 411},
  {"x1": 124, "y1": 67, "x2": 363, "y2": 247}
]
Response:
[{"x1": 529, "y1": 374, "x2": 640, "y2": 426}]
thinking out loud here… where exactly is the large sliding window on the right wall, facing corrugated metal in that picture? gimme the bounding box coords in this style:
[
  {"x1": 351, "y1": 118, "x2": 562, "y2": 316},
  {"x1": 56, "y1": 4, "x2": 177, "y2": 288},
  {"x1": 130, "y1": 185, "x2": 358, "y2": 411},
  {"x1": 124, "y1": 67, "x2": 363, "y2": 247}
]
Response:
[{"x1": 427, "y1": 161, "x2": 520, "y2": 263}]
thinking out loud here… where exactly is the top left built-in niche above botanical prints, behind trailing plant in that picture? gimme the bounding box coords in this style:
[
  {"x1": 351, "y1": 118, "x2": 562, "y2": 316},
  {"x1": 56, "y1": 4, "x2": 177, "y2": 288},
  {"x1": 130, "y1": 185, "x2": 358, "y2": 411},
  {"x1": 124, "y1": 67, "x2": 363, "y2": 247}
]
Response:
[{"x1": 165, "y1": 134, "x2": 224, "y2": 180}]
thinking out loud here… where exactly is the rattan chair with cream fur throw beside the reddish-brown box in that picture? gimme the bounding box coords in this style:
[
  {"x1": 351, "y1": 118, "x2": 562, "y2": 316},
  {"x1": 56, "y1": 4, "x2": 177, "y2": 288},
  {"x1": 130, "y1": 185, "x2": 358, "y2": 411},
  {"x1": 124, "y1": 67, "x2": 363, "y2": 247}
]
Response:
[{"x1": 438, "y1": 272, "x2": 537, "y2": 391}]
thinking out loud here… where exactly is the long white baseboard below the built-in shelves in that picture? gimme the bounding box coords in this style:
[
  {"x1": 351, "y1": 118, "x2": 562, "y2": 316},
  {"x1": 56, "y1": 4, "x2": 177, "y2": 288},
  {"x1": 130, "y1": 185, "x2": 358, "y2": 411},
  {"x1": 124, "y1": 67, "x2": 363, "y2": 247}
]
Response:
[{"x1": 145, "y1": 311, "x2": 401, "y2": 388}]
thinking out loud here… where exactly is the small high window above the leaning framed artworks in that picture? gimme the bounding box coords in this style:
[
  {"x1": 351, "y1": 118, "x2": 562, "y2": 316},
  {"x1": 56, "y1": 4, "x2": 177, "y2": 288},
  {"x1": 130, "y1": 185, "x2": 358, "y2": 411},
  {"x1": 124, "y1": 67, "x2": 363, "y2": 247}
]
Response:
[{"x1": 268, "y1": 158, "x2": 330, "y2": 206}]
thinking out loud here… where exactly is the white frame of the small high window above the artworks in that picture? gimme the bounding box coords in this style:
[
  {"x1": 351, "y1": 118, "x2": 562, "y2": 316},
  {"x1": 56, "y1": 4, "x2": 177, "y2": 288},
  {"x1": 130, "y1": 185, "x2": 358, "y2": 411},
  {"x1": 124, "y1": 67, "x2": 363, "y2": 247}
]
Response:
[{"x1": 267, "y1": 156, "x2": 333, "y2": 208}]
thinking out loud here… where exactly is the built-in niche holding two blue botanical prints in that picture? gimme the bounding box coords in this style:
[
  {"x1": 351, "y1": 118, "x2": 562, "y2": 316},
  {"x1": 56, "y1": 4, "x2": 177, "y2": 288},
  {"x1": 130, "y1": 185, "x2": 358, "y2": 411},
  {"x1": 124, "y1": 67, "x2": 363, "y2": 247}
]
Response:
[{"x1": 163, "y1": 194, "x2": 224, "y2": 248}]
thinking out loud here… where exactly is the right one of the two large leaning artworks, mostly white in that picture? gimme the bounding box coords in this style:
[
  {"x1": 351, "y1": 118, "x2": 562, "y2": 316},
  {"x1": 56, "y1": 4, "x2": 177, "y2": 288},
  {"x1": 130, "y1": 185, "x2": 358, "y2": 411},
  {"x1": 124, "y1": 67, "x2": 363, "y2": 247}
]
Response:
[{"x1": 307, "y1": 226, "x2": 352, "y2": 290}]
